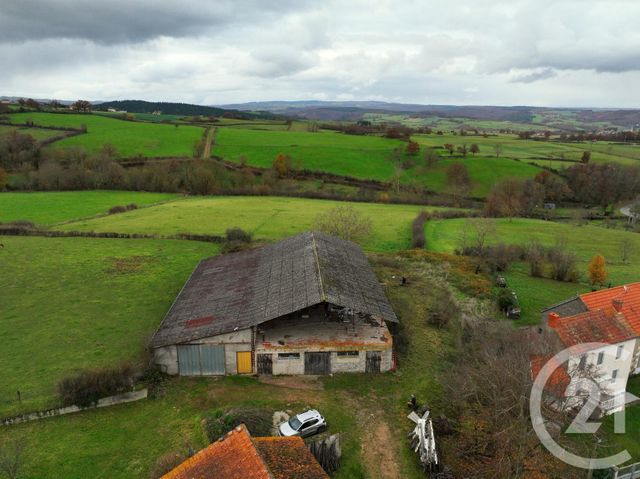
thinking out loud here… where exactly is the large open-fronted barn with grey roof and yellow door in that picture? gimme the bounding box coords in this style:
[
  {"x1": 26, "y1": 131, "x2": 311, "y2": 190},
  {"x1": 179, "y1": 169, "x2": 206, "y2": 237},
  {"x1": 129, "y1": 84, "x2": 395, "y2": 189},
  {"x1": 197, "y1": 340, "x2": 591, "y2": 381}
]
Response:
[{"x1": 151, "y1": 232, "x2": 398, "y2": 376}]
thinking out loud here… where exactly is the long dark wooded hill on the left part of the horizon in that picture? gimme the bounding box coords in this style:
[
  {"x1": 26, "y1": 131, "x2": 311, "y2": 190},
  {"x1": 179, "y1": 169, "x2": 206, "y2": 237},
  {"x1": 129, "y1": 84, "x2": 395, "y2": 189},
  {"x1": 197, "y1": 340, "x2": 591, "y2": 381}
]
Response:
[{"x1": 94, "y1": 100, "x2": 278, "y2": 120}]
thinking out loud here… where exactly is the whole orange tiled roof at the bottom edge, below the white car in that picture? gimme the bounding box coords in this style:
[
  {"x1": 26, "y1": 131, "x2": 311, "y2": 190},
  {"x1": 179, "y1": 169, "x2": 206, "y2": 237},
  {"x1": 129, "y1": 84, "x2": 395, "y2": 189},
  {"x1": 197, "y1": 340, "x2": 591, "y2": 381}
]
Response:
[{"x1": 162, "y1": 424, "x2": 329, "y2": 479}]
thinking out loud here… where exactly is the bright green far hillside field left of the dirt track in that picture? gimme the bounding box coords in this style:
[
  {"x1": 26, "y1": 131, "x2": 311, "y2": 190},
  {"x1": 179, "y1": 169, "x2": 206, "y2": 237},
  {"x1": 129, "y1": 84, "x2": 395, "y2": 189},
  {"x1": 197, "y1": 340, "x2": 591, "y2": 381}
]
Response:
[{"x1": 9, "y1": 112, "x2": 203, "y2": 157}]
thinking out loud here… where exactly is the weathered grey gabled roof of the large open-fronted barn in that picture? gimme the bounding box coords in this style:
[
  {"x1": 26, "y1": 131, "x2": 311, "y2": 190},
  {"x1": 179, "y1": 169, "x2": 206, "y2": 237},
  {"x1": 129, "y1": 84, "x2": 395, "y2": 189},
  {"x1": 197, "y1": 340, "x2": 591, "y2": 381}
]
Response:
[{"x1": 152, "y1": 232, "x2": 398, "y2": 347}]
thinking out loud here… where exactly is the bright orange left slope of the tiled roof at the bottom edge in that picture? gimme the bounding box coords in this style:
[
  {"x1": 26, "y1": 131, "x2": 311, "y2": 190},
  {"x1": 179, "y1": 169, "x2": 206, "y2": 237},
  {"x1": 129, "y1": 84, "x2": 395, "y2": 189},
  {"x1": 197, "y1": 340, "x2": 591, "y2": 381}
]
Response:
[{"x1": 162, "y1": 425, "x2": 273, "y2": 479}]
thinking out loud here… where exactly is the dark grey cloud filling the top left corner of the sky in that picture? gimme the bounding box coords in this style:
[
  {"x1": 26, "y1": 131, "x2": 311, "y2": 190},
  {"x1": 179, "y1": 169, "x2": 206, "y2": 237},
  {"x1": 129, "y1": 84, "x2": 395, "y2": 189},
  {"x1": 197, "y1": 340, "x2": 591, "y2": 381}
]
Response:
[{"x1": 0, "y1": 0, "x2": 306, "y2": 44}]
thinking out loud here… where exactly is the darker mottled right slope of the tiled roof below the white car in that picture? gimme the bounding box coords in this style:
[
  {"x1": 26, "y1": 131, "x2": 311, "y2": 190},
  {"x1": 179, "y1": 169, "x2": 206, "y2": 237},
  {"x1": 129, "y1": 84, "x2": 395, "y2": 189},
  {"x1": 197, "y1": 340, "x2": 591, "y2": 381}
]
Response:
[{"x1": 253, "y1": 437, "x2": 329, "y2": 479}]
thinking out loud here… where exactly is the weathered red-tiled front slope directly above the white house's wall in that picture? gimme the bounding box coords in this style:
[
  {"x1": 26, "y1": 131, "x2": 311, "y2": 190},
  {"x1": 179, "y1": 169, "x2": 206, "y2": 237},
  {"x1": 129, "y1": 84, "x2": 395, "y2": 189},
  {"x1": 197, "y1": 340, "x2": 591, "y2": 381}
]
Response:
[{"x1": 554, "y1": 309, "x2": 638, "y2": 346}]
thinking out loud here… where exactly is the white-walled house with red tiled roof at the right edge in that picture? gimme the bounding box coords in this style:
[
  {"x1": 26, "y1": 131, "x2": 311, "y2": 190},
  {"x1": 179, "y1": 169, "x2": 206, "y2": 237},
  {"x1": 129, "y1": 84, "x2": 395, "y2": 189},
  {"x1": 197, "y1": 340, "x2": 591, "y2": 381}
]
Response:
[{"x1": 542, "y1": 283, "x2": 640, "y2": 413}]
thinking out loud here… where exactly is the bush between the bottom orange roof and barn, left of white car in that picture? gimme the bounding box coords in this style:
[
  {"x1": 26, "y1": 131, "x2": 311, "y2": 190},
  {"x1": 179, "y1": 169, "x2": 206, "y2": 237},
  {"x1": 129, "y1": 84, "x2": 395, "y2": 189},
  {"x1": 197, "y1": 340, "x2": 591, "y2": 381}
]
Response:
[{"x1": 204, "y1": 407, "x2": 273, "y2": 443}]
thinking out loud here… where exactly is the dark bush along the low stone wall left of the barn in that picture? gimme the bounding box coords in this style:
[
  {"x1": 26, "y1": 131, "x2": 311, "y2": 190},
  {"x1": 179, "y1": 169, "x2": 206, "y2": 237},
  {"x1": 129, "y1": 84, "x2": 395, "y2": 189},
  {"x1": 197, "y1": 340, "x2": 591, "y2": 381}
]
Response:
[{"x1": 58, "y1": 364, "x2": 134, "y2": 407}]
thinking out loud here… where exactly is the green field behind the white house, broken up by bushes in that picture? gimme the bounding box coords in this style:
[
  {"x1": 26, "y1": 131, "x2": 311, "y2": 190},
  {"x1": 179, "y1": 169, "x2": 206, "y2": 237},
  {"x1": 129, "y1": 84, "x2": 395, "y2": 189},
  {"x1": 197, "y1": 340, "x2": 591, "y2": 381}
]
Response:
[{"x1": 426, "y1": 218, "x2": 640, "y2": 323}]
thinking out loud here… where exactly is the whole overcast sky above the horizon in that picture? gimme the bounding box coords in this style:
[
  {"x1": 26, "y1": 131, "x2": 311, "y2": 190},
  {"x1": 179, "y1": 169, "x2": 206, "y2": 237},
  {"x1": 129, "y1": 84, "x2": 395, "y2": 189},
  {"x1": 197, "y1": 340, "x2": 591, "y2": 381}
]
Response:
[{"x1": 0, "y1": 0, "x2": 640, "y2": 107}]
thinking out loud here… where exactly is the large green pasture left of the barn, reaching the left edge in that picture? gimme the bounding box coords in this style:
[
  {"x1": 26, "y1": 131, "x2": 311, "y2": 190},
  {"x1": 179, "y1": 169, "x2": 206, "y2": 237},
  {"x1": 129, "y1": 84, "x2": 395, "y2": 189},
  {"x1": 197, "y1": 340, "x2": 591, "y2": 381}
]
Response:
[{"x1": 0, "y1": 236, "x2": 217, "y2": 415}]
